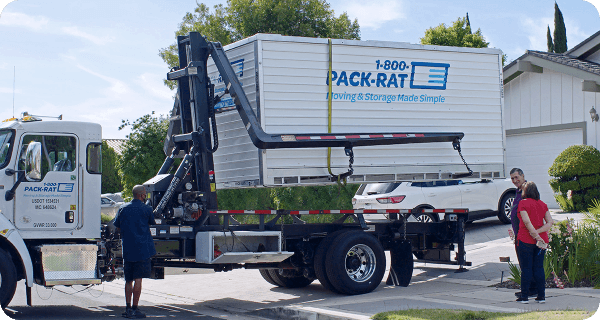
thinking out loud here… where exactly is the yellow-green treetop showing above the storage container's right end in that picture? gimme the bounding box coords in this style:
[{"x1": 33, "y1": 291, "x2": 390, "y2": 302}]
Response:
[{"x1": 421, "y1": 18, "x2": 489, "y2": 48}]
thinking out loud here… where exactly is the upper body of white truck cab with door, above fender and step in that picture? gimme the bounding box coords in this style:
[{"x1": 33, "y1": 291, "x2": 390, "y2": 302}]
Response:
[{"x1": 0, "y1": 117, "x2": 102, "y2": 239}]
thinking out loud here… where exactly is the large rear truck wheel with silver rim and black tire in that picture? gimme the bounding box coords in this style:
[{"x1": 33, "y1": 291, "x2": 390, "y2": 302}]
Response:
[{"x1": 325, "y1": 231, "x2": 385, "y2": 295}]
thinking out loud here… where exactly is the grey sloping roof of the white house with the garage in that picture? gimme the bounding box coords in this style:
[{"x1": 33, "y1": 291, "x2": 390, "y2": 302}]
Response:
[{"x1": 503, "y1": 31, "x2": 600, "y2": 85}]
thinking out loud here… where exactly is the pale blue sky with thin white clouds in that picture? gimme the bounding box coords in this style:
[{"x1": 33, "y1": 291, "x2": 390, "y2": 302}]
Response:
[{"x1": 0, "y1": 0, "x2": 600, "y2": 139}]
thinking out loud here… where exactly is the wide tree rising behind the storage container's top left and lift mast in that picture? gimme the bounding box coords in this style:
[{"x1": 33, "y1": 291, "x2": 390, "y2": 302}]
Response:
[{"x1": 159, "y1": 0, "x2": 360, "y2": 89}]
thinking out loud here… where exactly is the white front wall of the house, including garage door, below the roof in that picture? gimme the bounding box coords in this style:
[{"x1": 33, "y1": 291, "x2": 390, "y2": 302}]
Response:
[{"x1": 503, "y1": 68, "x2": 600, "y2": 208}]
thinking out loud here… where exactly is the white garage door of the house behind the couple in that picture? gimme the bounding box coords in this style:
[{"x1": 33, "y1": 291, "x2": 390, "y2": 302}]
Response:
[{"x1": 506, "y1": 128, "x2": 583, "y2": 209}]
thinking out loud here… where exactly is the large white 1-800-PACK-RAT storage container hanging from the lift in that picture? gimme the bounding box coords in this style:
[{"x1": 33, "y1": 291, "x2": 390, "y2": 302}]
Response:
[{"x1": 208, "y1": 34, "x2": 506, "y2": 188}]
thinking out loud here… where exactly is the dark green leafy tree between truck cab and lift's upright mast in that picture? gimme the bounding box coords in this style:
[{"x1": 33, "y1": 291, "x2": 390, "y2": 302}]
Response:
[{"x1": 118, "y1": 112, "x2": 169, "y2": 197}]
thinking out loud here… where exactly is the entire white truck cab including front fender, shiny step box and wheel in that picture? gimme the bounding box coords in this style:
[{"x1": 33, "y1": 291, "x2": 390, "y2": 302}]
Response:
[{"x1": 0, "y1": 116, "x2": 102, "y2": 307}]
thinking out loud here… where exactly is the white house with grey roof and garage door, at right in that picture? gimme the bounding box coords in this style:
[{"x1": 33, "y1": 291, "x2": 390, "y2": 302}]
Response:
[{"x1": 503, "y1": 31, "x2": 600, "y2": 208}]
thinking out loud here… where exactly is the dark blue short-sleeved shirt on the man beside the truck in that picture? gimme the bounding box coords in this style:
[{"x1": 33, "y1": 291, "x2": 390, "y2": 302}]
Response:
[{"x1": 115, "y1": 199, "x2": 156, "y2": 261}]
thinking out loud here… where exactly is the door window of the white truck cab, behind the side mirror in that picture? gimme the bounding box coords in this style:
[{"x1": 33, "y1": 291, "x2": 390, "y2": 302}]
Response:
[{"x1": 19, "y1": 135, "x2": 77, "y2": 180}]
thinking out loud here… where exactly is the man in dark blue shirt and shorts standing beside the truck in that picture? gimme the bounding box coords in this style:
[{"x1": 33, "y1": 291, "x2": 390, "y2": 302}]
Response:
[{"x1": 115, "y1": 185, "x2": 156, "y2": 318}]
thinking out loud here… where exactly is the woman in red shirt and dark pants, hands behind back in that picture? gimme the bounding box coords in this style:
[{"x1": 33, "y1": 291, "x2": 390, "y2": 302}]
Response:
[{"x1": 517, "y1": 181, "x2": 553, "y2": 303}]
